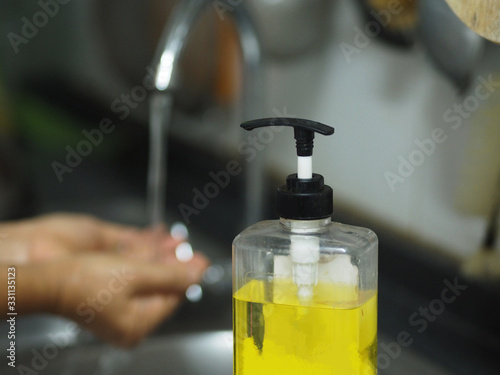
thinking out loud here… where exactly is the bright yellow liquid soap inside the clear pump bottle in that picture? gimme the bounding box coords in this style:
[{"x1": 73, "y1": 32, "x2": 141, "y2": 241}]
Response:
[{"x1": 233, "y1": 279, "x2": 377, "y2": 375}]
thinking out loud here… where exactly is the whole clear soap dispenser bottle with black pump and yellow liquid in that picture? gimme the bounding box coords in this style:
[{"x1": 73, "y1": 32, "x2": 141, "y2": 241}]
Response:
[{"x1": 233, "y1": 118, "x2": 378, "y2": 375}]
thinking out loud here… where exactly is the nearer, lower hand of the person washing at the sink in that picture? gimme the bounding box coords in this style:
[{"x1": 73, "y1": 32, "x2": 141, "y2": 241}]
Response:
[{"x1": 17, "y1": 254, "x2": 208, "y2": 346}]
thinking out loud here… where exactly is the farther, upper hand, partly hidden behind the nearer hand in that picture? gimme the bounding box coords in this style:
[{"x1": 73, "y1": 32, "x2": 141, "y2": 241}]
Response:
[{"x1": 0, "y1": 214, "x2": 180, "y2": 264}]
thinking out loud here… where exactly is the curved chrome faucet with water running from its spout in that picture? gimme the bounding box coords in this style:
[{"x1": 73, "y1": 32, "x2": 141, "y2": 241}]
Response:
[{"x1": 152, "y1": 0, "x2": 264, "y2": 228}]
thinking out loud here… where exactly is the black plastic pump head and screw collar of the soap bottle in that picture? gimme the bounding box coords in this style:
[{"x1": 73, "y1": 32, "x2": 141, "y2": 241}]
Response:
[{"x1": 241, "y1": 118, "x2": 334, "y2": 220}]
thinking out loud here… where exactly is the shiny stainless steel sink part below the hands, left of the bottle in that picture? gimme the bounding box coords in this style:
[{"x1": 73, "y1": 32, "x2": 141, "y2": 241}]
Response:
[{"x1": 17, "y1": 331, "x2": 233, "y2": 375}]
